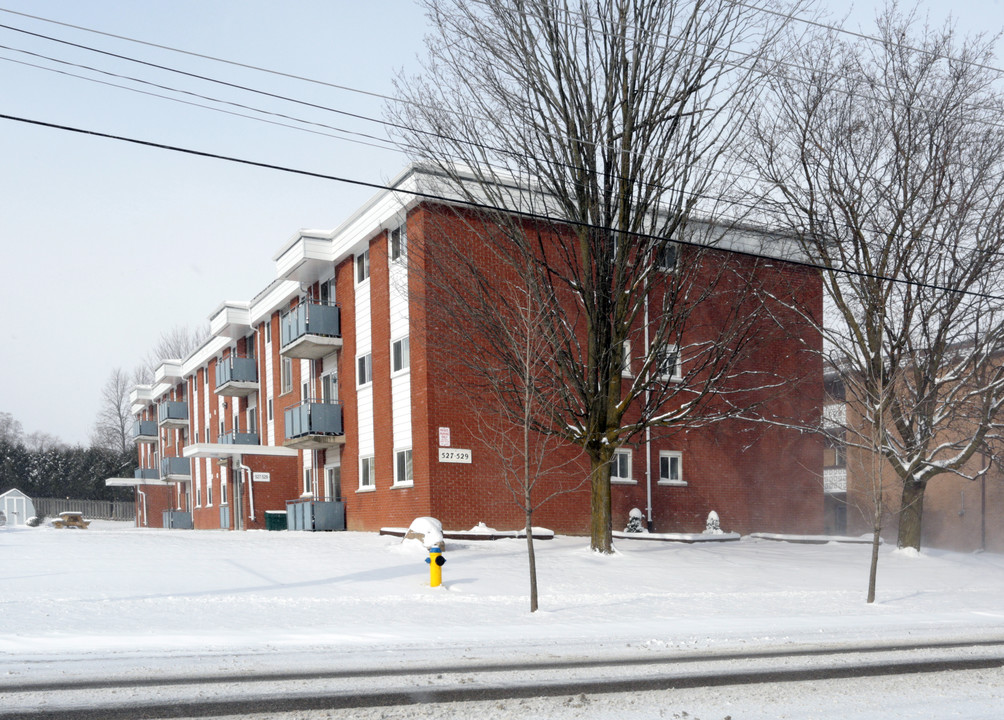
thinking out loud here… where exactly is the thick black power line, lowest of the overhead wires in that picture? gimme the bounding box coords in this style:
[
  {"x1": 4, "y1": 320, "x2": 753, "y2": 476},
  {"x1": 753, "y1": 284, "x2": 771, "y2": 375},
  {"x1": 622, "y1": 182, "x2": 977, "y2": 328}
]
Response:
[{"x1": 0, "y1": 113, "x2": 1004, "y2": 301}]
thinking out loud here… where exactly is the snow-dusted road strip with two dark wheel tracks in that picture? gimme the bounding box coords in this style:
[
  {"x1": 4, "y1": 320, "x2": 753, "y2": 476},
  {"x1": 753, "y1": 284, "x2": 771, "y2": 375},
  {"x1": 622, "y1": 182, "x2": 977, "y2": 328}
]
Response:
[{"x1": 0, "y1": 640, "x2": 1004, "y2": 720}]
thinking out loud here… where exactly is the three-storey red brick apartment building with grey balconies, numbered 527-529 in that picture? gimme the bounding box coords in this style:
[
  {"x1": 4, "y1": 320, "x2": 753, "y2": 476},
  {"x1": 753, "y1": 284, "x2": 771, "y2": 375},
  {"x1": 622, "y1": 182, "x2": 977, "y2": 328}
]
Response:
[{"x1": 109, "y1": 168, "x2": 823, "y2": 533}]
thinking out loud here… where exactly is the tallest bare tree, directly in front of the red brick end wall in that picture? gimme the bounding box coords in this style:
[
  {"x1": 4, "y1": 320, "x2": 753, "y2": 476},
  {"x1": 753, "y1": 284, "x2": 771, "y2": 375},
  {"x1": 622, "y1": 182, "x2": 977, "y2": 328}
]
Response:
[{"x1": 390, "y1": 0, "x2": 803, "y2": 552}]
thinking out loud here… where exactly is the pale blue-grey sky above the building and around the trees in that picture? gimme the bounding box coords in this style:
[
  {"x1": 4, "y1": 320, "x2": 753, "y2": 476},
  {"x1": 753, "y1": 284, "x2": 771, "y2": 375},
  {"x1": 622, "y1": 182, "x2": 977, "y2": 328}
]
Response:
[{"x1": 0, "y1": 0, "x2": 1004, "y2": 444}]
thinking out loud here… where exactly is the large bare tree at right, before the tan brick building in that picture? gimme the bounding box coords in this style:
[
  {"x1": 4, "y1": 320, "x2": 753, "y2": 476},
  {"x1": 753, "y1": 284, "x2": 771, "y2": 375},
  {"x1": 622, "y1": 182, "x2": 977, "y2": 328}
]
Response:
[{"x1": 750, "y1": 6, "x2": 1004, "y2": 549}]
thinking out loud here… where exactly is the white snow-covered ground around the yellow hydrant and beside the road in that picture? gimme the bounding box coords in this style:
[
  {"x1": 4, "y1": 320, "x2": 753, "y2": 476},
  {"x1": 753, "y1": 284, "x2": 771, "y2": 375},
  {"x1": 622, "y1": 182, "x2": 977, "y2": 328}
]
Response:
[{"x1": 0, "y1": 521, "x2": 1004, "y2": 720}]
